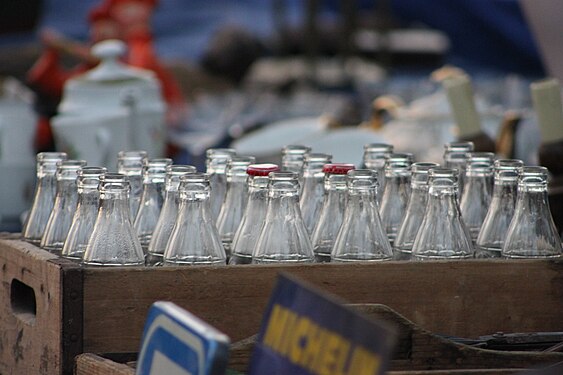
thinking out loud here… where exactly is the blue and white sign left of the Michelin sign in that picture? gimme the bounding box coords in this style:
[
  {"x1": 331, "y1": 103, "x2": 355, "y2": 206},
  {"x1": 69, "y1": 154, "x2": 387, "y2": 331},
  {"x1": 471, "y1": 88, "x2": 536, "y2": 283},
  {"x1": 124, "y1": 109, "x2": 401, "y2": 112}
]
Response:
[{"x1": 137, "y1": 302, "x2": 230, "y2": 375}]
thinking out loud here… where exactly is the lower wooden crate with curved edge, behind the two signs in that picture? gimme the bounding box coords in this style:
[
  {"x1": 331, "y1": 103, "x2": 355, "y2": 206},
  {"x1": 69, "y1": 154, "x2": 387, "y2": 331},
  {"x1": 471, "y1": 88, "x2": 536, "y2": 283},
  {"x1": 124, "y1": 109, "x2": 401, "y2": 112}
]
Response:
[{"x1": 75, "y1": 304, "x2": 563, "y2": 375}]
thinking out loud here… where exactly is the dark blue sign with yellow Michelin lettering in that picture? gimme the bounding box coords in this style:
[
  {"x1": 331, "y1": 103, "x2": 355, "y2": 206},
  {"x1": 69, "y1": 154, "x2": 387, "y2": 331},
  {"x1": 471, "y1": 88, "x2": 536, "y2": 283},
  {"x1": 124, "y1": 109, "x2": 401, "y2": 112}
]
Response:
[{"x1": 248, "y1": 274, "x2": 395, "y2": 375}]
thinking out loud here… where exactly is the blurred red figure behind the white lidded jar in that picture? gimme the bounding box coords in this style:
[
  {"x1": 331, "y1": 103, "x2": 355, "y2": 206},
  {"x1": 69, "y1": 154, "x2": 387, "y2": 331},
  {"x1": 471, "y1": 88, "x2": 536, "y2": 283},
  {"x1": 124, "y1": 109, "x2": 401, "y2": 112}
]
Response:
[{"x1": 27, "y1": 0, "x2": 186, "y2": 157}]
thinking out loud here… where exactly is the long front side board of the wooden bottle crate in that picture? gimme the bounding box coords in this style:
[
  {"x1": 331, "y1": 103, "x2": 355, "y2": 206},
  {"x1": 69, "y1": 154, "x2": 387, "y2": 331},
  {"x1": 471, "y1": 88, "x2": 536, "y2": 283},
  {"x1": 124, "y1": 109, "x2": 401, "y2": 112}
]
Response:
[{"x1": 84, "y1": 260, "x2": 563, "y2": 352}]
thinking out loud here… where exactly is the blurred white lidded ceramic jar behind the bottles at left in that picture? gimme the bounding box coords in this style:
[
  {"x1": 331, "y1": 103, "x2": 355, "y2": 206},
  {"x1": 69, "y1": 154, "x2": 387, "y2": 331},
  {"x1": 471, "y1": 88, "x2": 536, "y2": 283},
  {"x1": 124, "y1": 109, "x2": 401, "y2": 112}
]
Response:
[{"x1": 51, "y1": 40, "x2": 166, "y2": 167}]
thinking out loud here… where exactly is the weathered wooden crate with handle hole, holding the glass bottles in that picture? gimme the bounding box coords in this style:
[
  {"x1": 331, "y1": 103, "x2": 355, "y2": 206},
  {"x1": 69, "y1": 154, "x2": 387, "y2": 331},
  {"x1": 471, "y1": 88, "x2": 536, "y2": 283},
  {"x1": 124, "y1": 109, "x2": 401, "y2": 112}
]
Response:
[{"x1": 0, "y1": 239, "x2": 563, "y2": 374}]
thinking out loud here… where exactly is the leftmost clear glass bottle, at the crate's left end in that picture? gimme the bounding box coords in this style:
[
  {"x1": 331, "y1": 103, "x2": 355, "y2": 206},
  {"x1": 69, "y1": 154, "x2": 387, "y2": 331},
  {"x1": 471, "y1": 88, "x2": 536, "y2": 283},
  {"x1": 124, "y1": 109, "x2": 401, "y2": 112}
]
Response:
[{"x1": 22, "y1": 152, "x2": 67, "y2": 245}]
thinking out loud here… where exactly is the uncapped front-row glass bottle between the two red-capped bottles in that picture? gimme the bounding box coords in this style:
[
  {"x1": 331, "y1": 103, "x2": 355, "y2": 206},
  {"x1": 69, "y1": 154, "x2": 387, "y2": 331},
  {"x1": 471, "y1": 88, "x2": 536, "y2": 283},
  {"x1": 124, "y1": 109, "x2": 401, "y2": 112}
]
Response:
[{"x1": 252, "y1": 172, "x2": 314, "y2": 263}]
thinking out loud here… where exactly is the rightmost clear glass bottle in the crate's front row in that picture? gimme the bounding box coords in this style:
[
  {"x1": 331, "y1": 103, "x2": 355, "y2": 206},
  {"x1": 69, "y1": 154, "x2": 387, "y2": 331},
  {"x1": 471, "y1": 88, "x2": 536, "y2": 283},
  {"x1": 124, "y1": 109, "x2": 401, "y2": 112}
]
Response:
[{"x1": 502, "y1": 167, "x2": 563, "y2": 258}]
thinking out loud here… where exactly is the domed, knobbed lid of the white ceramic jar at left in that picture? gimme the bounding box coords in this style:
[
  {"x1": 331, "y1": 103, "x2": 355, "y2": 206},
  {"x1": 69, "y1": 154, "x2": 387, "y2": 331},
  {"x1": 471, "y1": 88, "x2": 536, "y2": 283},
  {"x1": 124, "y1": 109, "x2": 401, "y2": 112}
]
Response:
[{"x1": 59, "y1": 40, "x2": 165, "y2": 116}]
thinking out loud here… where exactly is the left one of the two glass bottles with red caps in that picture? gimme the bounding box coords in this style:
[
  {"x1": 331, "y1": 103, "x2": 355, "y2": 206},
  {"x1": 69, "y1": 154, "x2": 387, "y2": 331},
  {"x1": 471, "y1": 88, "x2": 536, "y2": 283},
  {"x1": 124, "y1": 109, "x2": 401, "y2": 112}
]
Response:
[{"x1": 229, "y1": 164, "x2": 279, "y2": 264}]
